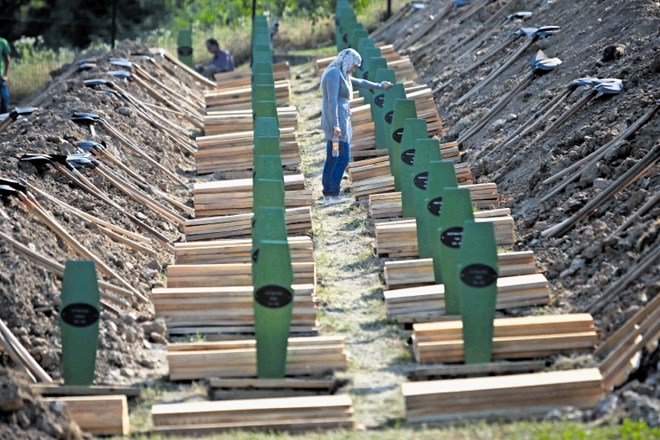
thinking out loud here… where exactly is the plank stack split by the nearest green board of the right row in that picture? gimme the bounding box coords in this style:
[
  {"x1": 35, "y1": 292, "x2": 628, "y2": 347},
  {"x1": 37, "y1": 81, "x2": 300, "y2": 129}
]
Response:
[{"x1": 412, "y1": 313, "x2": 598, "y2": 364}]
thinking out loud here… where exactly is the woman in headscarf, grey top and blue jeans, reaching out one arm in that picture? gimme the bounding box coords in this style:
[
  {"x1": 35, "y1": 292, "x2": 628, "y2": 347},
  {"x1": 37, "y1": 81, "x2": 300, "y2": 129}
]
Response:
[{"x1": 321, "y1": 49, "x2": 392, "y2": 205}]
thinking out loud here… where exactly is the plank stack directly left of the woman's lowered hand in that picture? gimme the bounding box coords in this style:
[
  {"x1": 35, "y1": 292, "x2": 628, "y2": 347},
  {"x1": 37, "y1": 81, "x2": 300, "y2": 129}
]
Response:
[{"x1": 195, "y1": 128, "x2": 300, "y2": 174}]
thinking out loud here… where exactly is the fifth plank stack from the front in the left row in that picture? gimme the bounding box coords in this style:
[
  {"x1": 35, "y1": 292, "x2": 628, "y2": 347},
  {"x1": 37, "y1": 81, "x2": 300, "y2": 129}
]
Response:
[{"x1": 174, "y1": 236, "x2": 314, "y2": 264}]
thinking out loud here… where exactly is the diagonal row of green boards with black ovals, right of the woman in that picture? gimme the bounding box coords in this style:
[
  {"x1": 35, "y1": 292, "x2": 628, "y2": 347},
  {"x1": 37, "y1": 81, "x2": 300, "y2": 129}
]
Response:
[{"x1": 335, "y1": 0, "x2": 498, "y2": 363}]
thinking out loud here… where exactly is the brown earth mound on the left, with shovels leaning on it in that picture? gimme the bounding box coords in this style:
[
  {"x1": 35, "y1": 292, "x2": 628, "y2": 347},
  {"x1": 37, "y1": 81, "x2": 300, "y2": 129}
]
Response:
[{"x1": 0, "y1": 43, "x2": 204, "y2": 392}]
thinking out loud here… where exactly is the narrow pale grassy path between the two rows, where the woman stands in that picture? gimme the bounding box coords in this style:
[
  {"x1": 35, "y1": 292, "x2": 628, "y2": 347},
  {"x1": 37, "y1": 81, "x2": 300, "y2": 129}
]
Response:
[{"x1": 291, "y1": 58, "x2": 411, "y2": 428}]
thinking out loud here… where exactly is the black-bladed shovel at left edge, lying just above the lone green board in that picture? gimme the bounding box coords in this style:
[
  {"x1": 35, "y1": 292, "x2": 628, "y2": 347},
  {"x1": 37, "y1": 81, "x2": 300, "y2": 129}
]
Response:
[{"x1": 0, "y1": 178, "x2": 147, "y2": 302}]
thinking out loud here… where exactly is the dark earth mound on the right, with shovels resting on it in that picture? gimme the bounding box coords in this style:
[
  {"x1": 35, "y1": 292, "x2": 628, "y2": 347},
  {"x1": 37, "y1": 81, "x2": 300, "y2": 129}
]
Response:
[{"x1": 374, "y1": 0, "x2": 660, "y2": 423}]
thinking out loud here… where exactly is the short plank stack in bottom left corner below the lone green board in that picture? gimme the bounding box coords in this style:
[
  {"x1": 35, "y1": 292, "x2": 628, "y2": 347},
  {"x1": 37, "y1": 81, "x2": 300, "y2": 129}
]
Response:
[{"x1": 44, "y1": 395, "x2": 130, "y2": 435}]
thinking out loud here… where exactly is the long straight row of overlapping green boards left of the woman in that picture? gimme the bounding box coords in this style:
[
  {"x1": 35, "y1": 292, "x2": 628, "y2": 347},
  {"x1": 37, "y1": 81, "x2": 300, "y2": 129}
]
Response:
[{"x1": 252, "y1": 16, "x2": 293, "y2": 378}]
